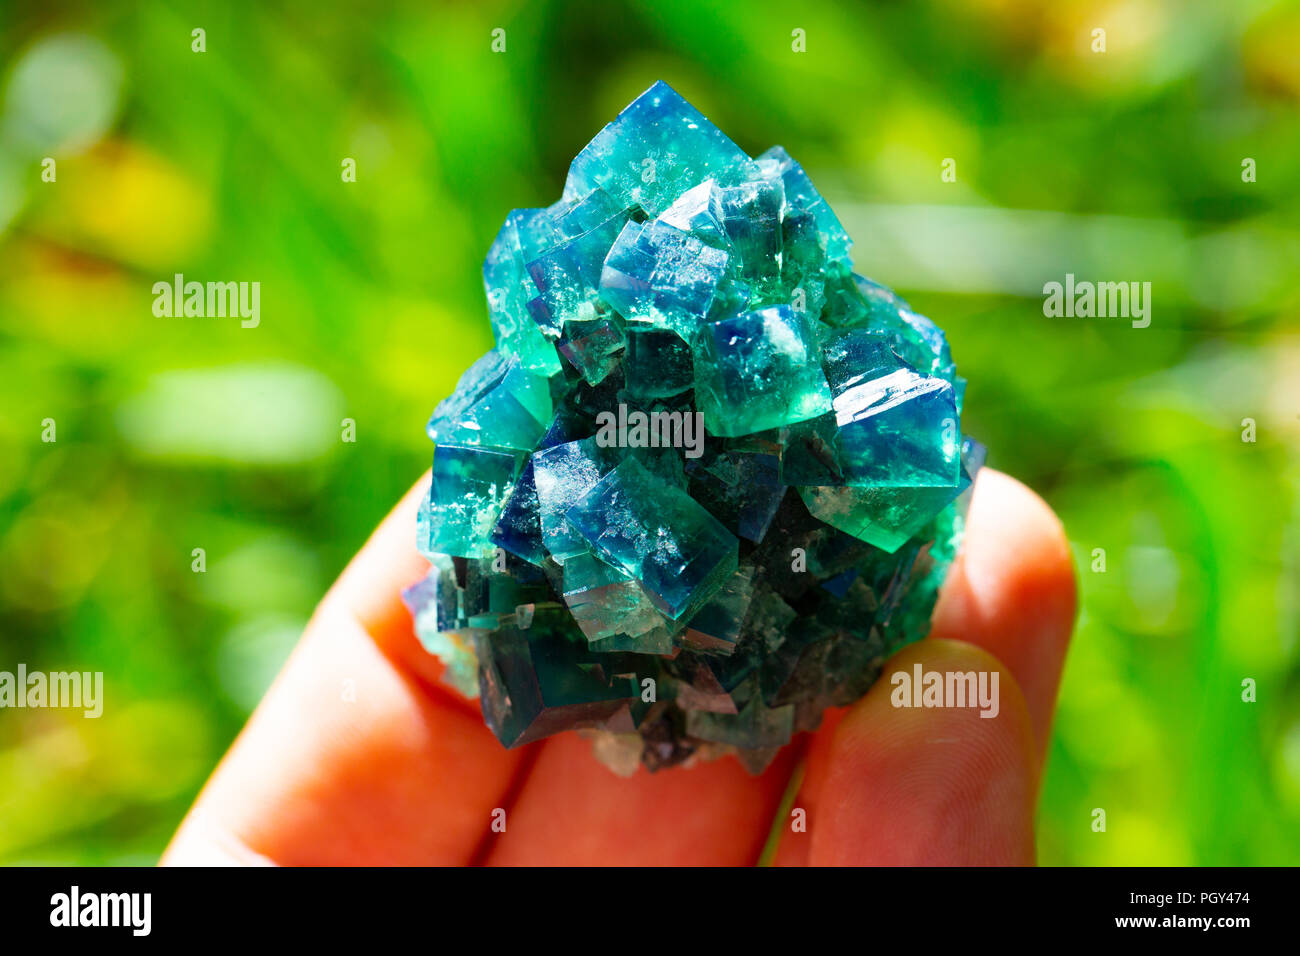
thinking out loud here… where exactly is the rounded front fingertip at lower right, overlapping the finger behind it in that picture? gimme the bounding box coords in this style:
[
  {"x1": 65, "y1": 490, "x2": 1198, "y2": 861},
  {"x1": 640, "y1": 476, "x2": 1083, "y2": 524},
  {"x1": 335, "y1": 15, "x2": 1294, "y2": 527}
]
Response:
[{"x1": 777, "y1": 640, "x2": 1036, "y2": 866}]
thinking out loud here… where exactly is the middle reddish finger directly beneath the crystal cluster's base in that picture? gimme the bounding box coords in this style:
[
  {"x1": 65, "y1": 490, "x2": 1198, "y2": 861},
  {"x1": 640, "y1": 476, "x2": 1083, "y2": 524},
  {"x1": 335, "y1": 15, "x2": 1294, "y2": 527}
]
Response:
[{"x1": 488, "y1": 734, "x2": 796, "y2": 866}]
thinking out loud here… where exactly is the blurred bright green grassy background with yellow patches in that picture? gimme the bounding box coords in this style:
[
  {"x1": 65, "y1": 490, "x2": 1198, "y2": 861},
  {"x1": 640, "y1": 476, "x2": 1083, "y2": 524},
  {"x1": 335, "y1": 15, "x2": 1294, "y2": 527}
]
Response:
[{"x1": 0, "y1": 0, "x2": 1300, "y2": 865}]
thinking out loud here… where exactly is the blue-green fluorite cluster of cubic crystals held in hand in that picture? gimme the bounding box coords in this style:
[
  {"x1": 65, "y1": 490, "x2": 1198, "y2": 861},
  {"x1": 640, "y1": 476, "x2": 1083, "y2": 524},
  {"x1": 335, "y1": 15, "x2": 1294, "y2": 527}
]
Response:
[{"x1": 406, "y1": 83, "x2": 982, "y2": 771}]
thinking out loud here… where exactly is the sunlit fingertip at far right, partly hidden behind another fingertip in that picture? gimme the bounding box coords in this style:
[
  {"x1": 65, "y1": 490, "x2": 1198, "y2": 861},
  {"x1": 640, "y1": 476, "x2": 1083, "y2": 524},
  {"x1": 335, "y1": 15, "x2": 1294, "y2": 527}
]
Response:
[{"x1": 931, "y1": 468, "x2": 1075, "y2": 763}]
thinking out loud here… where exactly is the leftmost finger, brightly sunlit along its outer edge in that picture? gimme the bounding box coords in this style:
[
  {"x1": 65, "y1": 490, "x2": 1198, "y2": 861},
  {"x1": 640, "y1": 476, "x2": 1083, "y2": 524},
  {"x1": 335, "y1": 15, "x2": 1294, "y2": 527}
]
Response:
[{"x1": 164, "y1": 473, "x2": 527, "y2": 864}]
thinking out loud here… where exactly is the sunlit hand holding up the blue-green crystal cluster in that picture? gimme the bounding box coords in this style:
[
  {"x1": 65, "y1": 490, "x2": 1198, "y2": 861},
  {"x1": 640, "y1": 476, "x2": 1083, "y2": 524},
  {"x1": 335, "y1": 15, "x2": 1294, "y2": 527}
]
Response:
[{"x1": 163, "y1": 468, "x2": 1075, "y2": 865}]
